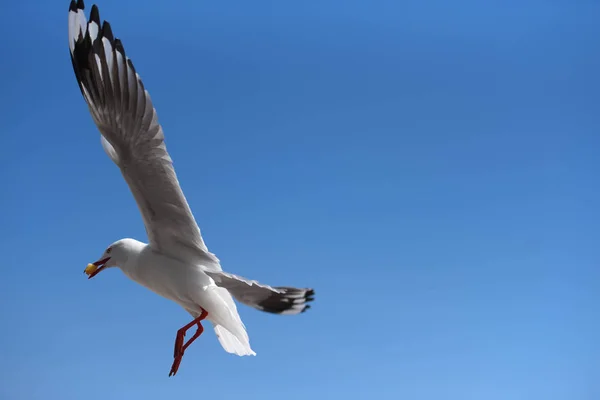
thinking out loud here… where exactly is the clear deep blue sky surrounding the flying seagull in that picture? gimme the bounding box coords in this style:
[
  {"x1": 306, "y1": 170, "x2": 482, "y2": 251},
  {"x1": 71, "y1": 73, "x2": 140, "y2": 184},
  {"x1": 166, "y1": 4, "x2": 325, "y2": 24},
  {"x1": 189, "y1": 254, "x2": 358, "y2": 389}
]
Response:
[{"x1": 0, "y1": 0, "x2": 600, "y2": 400}]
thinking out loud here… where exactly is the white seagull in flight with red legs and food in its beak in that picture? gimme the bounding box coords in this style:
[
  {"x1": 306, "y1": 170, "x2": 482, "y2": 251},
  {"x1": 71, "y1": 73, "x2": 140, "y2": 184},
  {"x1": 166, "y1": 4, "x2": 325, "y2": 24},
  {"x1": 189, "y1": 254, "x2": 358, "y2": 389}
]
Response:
[{"x1": 69, "y1": 0, "x2": 315, "y2": 376}]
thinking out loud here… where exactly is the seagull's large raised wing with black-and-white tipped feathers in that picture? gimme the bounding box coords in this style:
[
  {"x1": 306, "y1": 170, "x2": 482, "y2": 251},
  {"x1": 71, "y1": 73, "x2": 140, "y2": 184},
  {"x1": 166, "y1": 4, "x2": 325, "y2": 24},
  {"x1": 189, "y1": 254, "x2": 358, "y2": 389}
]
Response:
[{"x1": 69, "y1": 0, "x2": 221, "y2": 270}]
